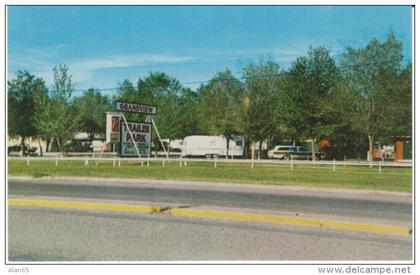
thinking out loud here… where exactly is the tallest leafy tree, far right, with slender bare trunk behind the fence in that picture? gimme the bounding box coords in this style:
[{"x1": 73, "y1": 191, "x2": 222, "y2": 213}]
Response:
[{"x1": 340, "y1": 33, "x2": 411, "y2": 160}]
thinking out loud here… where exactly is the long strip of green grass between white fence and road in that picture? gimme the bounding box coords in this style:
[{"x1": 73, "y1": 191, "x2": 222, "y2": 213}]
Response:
[{"x1": 8, "y1": 160, "x2": 412, "y2": 192}]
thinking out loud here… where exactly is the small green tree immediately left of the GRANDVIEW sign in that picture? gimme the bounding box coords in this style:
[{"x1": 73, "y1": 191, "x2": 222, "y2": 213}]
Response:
[{"x1": 74, "y1": 88, "x2": 112, "y2": 142}]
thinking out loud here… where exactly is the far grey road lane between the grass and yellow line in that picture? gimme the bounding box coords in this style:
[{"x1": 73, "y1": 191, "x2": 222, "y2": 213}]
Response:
[{"x1": 8, "y1": 179, "x2": 412, "y2": 225}]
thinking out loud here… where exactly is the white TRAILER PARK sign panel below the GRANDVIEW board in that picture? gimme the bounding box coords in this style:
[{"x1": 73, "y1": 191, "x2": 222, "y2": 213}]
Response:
[{"x1": 120, "y1": 121, "x2": 152, "y2": 157}]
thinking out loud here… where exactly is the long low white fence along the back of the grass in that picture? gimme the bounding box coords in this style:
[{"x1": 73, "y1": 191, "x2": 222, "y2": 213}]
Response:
[{"x1": 8, "y1": 155, "x2": 413, "y2": 169}]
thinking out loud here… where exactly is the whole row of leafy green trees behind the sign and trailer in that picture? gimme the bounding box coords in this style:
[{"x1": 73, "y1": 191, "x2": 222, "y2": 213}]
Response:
[{"x1": 8, "y1": 33, "x2": 412, "y2": 161}]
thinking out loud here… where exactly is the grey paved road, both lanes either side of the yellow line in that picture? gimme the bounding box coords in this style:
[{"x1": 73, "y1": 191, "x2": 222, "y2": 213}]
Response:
[{"x1": 8, "y1": 179, "x2": 412, "y2": 261}]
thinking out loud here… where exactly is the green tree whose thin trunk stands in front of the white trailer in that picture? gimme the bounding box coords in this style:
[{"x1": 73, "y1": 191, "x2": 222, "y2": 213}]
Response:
[{"x1": 201, "y1": 70, "x2": 245, "y2": 158}]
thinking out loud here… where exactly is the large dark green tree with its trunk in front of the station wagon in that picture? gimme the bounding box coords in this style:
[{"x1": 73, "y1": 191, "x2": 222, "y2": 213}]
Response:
[{"x1": 284, "y1": 47, "x2": 340, "y2": 159}]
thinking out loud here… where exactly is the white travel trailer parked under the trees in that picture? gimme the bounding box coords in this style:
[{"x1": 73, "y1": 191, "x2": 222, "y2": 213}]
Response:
[{"x1": 182, "y1": 136, "x2": 244, "y2": 158}]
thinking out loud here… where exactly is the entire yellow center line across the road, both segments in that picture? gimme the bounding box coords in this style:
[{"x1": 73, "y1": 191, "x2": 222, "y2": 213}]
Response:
[{"x1": 8, "y1": 198, "x2": 411, "y2": 237}]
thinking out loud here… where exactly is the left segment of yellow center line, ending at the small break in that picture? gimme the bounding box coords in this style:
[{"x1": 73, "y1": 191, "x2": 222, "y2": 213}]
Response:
[{"x1": 9, "y1": 199, "x2": 161, "y2": 216}]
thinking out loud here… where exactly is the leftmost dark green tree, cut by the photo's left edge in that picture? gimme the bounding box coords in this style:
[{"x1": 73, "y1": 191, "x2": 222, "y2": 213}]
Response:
[{"x1": 7, "y1": 71, "x2": 47, "y2": 154}]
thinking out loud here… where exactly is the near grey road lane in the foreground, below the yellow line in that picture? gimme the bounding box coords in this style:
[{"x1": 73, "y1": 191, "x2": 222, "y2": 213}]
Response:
[{"x1": 8, "y1": 207, "x2": 412, "y2": 261}]
